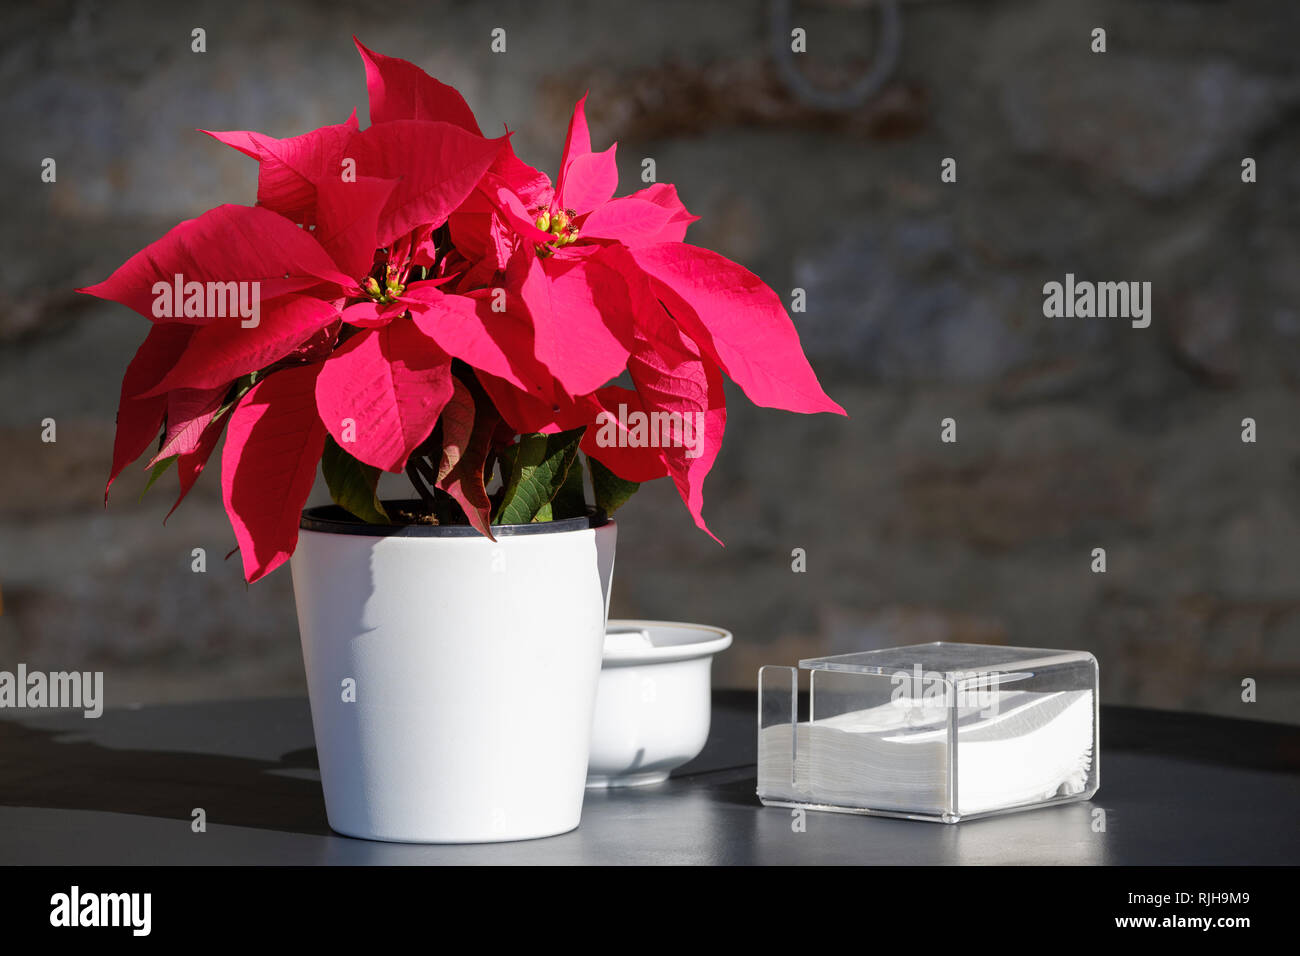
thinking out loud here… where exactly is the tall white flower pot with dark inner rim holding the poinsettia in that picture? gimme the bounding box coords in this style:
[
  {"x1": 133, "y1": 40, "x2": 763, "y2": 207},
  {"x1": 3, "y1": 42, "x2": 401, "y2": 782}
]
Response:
[{"x1": 291, "y1": 506, "x2": 616, "y2": 843}]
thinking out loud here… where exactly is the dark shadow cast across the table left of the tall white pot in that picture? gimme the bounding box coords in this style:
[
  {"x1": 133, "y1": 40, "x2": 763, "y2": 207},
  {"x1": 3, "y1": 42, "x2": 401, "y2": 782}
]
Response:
[{"x1": 0, "y1": 721, "x2": 333, "y2": 835}]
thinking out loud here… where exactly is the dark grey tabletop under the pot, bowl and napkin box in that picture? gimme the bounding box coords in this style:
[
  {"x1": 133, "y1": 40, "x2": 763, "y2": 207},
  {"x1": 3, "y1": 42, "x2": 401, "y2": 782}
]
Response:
[{"x1": 0, "y1": 692, "x2": 1300, "y2": 866}]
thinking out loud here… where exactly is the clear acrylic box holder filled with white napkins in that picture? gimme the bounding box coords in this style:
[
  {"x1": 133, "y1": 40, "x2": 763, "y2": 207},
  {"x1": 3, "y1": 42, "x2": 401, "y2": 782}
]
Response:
[{"x1": 758, "y1": 641, "x2": 1100, "y2": 823}]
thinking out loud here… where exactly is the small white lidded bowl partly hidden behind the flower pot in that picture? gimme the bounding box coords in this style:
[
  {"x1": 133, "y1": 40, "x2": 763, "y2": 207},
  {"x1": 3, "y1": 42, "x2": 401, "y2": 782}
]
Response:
[{"x1": 586, "y1": 620, "x2": 732, "y2": 787}]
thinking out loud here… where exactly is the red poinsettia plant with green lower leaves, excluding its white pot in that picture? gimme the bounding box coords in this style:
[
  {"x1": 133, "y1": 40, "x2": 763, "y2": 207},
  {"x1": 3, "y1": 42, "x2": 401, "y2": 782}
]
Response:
[{"x1": 79, "y1": 42, "x2": 844, "y2": 581}]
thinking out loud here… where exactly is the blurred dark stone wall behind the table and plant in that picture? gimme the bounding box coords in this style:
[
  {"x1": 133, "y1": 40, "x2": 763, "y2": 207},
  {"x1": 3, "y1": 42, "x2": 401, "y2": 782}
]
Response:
[{"x1": 0, "y1": 0, "x2": 1300, "y2": 721}]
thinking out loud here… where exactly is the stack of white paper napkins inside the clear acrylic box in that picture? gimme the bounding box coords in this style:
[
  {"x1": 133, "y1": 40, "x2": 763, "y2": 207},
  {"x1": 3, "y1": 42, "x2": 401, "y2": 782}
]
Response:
[{"x1": 759, "y1": 691, "x2": 1093, "y2": 816}]
